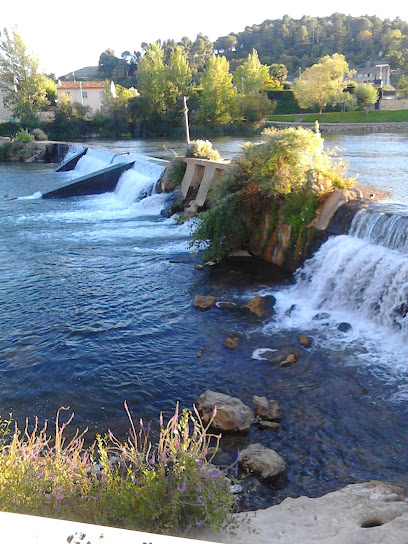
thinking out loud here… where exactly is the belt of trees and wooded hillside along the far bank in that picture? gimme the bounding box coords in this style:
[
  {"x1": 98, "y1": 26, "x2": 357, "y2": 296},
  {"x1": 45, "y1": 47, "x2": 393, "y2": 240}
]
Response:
[{"x1": 0, "y1": 13, "x2": 408, "y2": 139}]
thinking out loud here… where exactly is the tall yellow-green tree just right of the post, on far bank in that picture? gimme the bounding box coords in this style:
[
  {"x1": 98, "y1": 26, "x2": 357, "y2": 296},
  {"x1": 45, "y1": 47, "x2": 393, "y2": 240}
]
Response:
[{"x1": 201, "y1": 55, "x2": 236, "y2": 125}]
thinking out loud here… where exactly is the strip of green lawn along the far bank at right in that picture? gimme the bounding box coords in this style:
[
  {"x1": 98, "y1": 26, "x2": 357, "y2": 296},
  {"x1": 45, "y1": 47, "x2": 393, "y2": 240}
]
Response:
[{"x1": 268, "y1": 110, "x2": 408, "y2": 123}]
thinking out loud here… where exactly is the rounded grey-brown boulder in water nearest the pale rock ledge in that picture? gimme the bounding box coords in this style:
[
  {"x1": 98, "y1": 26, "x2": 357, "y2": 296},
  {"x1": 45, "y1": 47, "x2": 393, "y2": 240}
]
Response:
[{"x1": 239, "y1": 444, "x2": 286, "y2": 480}]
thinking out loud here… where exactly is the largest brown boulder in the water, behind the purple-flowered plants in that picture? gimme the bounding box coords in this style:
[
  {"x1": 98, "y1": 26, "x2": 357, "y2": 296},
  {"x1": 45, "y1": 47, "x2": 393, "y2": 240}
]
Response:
[{"x1": 198, "y1": 390, "x2": 255, "y2": 432}]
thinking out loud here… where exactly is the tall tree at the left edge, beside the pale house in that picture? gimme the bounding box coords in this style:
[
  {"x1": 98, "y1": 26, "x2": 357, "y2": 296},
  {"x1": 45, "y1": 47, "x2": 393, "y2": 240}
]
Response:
[{"x1": 0, "y1": 28, "x2": 49, "y2": 124}]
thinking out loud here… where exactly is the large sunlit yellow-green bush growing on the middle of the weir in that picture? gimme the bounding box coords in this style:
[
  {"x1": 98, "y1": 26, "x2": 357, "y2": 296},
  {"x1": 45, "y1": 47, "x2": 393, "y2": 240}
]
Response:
[{"x1": 193, "y1": 128, "x2": 354, "y2": 260}]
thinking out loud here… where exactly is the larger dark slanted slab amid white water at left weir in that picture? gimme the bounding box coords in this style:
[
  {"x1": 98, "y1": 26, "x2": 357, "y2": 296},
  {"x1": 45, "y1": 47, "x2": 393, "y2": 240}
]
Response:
[{"x1": 42, "y1": 161, "x2": 135, "y2": 198}]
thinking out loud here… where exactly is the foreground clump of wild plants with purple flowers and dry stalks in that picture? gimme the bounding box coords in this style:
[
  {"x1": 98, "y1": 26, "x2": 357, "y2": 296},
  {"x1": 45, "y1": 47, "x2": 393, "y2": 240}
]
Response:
[{"x1": 0, "y1": 403, "x2": 232, "y2": 534}]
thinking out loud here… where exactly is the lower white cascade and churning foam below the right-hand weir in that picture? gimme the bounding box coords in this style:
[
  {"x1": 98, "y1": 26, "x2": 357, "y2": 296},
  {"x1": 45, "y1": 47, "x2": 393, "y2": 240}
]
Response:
[{"x1": 258, "y1": 236, "x2": 408, "y2": 400}]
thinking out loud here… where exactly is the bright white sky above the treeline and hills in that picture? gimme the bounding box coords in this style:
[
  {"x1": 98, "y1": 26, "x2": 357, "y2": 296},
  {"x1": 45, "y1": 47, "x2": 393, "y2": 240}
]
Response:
[{"x1": 0, "y1": 0, "x2": 408, "y2": 77}]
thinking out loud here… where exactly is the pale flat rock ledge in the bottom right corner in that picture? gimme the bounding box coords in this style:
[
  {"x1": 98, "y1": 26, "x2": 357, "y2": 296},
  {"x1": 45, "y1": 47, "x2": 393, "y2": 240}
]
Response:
[{"x1": 202, "y1": 481, "x2": 408, "y2": 544}]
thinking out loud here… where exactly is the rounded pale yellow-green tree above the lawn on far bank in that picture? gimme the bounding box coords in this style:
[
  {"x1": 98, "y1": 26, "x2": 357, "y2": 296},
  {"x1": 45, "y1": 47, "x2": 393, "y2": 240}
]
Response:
[{"x1": 294, "y1": 53, "x2": 352, "y2": 116}]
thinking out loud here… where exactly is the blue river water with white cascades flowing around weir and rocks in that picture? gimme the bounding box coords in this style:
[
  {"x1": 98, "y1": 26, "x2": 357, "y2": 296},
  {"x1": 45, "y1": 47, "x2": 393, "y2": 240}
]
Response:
[{"x1": 0, "y1": 134, "x2": 408, "y2": 508}]
